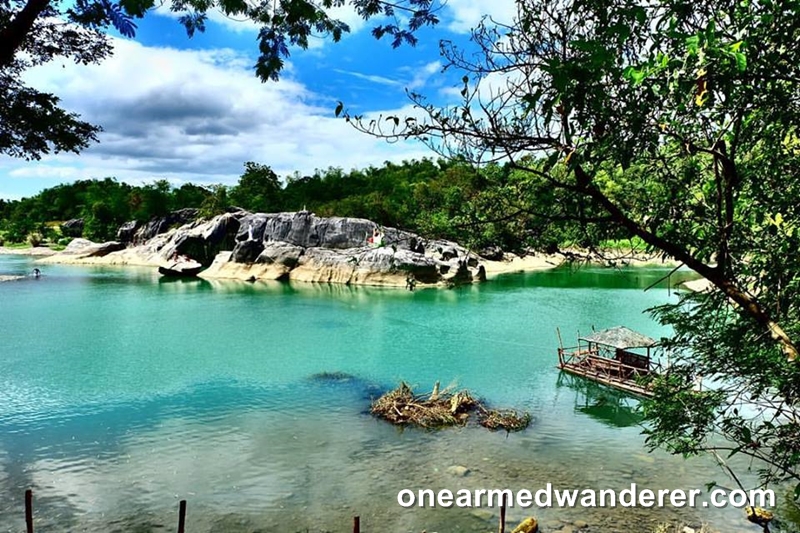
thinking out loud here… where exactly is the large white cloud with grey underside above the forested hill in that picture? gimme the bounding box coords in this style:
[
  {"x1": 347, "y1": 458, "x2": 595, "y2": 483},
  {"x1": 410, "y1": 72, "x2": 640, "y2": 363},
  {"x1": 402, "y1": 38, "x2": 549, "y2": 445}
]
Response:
[{"x1": 9, "y1": 40, "x2": 432, "y2": 188}]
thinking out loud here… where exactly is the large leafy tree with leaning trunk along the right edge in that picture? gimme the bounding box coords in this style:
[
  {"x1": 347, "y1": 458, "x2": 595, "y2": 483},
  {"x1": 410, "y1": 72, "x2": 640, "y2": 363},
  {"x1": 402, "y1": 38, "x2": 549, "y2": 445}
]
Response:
[{"x1": 344, "y1": 0, "x2": 800, "y2": 495}]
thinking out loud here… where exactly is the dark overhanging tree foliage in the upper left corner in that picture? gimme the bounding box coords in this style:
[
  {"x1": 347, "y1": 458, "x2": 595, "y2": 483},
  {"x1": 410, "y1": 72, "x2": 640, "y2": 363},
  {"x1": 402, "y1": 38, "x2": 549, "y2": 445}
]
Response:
[{"x1": 0, "y1": 0, "x2": 438, "y2": 159}]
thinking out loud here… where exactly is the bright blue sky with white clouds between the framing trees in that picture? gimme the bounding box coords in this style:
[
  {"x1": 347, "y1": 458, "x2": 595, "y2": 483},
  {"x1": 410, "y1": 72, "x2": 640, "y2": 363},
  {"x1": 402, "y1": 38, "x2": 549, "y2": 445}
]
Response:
[{"x1": 0, "y1": 0, "x2": 514, "y2": 199}]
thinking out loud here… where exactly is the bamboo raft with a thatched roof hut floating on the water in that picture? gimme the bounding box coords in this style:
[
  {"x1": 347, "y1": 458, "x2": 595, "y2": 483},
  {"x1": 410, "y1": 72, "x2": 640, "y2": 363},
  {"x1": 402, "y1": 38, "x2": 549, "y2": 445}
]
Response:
[{"x1": 558, "y1": 326, "x2": 662, "y2": 397}]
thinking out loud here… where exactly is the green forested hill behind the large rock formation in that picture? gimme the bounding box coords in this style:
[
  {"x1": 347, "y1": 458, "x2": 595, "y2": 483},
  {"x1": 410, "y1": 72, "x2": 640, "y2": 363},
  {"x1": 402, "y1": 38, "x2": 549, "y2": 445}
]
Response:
[{"x1": 0, "y1": 159, "x2": 615, "y2": 251}]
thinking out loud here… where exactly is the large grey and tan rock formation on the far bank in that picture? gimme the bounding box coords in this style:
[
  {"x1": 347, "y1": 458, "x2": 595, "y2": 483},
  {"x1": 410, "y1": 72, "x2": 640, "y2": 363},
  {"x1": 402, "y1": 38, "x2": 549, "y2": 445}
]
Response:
[{"x1": 45, "y1": 209, "x2": 494, "y2": 287}]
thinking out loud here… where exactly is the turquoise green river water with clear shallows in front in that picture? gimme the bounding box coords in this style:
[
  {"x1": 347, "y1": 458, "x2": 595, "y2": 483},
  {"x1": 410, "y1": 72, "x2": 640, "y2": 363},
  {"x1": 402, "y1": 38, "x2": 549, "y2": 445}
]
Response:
[{"x1": 0, "y1": 256, "x2": 757, "y2": 532}]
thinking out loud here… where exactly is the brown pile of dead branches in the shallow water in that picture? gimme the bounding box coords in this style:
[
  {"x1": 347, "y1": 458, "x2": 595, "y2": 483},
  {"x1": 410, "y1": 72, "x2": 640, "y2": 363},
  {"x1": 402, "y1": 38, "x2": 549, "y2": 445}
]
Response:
[{"x1": 370, "y1": 381, "x2": 531, "y2": 431}]
